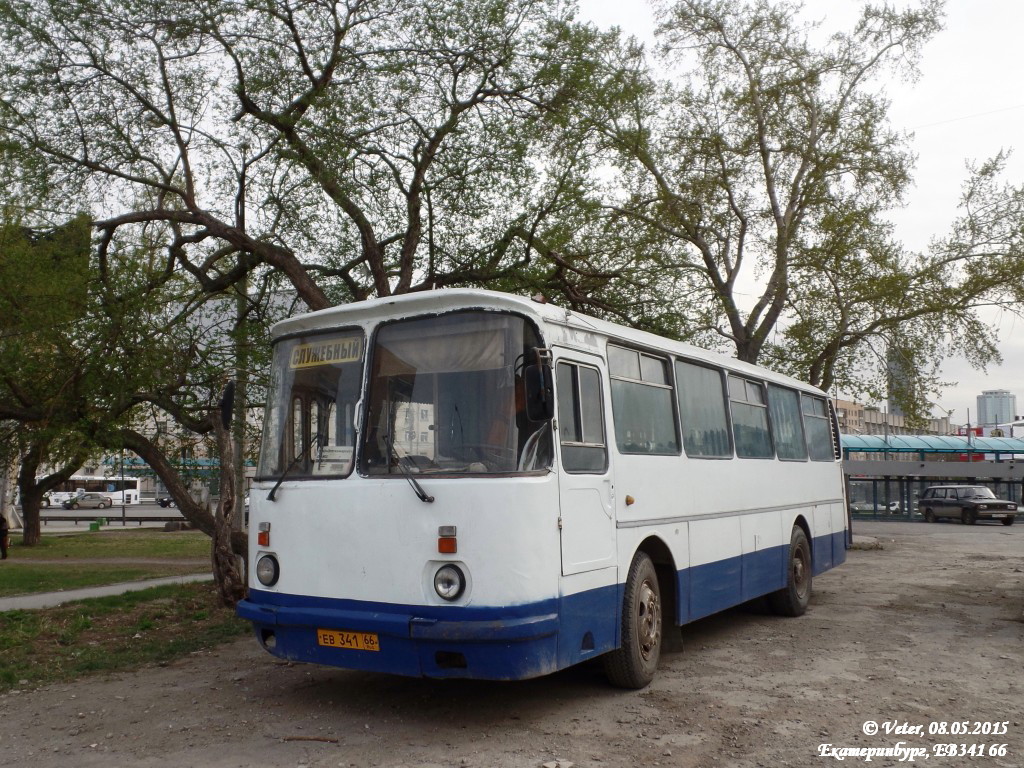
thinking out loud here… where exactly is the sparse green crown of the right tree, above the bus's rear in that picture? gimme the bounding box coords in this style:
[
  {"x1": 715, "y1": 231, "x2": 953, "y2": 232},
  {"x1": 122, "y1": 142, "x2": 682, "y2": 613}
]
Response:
[{"x1": 536, "y1": 0, "x2": 1022, "y2": 421}]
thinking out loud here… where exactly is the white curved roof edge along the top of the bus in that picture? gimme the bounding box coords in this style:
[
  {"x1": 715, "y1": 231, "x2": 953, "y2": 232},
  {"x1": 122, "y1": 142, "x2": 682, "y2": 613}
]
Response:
[{"x1": 271, "y1": 288, "x2": 825, "y2": 395}]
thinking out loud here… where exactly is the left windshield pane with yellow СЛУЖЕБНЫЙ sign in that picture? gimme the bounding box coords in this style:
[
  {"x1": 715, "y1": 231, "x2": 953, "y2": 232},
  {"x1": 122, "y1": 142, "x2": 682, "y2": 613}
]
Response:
[{"x1": 259, "y1": 330, "x2": 365, "y2": 478}]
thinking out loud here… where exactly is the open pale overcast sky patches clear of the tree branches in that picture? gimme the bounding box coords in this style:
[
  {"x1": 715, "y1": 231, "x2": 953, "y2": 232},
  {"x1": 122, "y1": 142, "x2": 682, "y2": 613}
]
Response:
[{"x1": 580, "y1": 0, "x2": 1024, "y2": 424}]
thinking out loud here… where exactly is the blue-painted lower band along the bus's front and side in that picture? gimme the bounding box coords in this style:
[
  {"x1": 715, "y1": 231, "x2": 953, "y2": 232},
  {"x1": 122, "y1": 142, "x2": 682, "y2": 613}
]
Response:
[{"x1": 238, "y1": 531, "x2": 846, "y2": 680}]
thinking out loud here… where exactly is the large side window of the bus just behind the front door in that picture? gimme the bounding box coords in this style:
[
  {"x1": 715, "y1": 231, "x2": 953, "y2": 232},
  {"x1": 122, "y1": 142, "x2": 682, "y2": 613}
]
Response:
[{"x1": 608, "y1": 344, "x2": 679, "y2": 455}]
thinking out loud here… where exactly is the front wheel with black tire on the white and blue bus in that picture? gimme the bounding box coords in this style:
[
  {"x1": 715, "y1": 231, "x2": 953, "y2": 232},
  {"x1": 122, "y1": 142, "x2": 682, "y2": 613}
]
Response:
[{"x1": 603, "y1": 552, "x2": 663, "y2": 689}]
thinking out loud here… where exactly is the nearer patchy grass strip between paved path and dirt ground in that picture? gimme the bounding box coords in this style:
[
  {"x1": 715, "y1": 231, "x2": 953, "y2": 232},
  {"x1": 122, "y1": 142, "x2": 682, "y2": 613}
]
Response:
[{"x1": 0, "y1": 584, "x2": 250, "y2": 691}]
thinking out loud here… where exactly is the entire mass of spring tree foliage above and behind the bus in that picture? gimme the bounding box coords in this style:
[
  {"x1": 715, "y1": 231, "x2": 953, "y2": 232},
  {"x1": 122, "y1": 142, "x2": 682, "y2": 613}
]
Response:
[{"x1": 0, "y1": 0, "x2": 1022, "y2": 438}]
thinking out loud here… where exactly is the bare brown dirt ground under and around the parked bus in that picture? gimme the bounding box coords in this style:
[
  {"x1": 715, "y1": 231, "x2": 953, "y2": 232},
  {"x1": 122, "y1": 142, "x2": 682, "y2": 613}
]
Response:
[{"x1": 0, "y1": 522, "x2": 1024, "y2": 768}]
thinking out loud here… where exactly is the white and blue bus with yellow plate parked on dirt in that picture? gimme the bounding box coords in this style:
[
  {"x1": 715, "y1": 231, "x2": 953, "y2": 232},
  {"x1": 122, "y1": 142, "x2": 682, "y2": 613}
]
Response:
[{"x1": 239, "y1": 290, "x2": 847, "y2": 688}]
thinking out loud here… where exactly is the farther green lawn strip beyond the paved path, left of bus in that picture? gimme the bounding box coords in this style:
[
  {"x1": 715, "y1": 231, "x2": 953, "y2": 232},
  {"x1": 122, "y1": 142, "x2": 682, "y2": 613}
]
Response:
[{"x1": 0, "y1": 528, "x2": 210, "y2": 597}]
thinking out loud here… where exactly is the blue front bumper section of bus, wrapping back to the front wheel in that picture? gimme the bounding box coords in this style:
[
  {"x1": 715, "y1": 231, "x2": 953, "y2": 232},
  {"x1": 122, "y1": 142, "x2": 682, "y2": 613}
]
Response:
[{"x1": 238, "y1": 587, "x2": 618, "y2": 680}]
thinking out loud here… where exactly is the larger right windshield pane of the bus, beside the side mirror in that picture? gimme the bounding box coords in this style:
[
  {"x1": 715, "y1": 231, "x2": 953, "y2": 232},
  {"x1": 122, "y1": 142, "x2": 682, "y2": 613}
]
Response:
[{"x1": 360, "y1": 311, "x2": 552, "y2": 475}]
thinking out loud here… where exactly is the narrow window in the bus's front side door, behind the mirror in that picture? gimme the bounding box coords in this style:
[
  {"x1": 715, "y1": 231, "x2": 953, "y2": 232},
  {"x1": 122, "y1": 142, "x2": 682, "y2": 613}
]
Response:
[{"x1": 555, "y1": 362, "x2": 608, "y2": 473}]
